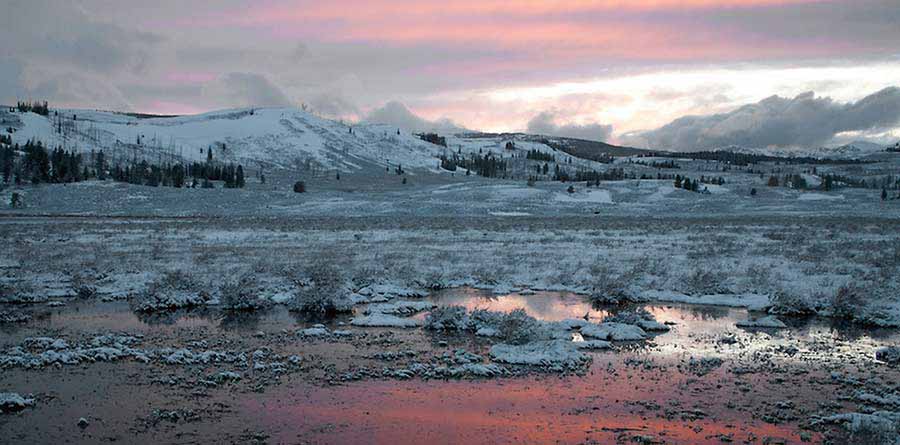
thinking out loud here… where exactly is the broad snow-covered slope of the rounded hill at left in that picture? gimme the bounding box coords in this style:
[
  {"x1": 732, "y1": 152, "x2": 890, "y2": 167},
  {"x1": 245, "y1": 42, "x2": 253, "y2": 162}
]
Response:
[{"x1": 0, "y1": 108, "x2": 450, "y2": 171}]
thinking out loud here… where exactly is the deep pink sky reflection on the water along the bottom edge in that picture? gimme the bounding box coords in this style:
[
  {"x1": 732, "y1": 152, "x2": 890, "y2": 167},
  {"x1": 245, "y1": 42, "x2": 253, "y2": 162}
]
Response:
[{"x1": 240, "y1": 369, "x2": 824, "y2": 444}]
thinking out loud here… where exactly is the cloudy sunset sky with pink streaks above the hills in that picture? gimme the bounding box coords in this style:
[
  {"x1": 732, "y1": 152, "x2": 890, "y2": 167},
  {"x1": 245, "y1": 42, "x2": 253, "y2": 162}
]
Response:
[{"x1": 0, "y1": 0, "x2": 900, "y2": 149}]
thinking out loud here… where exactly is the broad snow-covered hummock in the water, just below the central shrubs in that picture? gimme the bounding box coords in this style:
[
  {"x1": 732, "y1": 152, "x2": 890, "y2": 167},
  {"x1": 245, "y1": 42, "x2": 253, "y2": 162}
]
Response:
[{"x1": 491, "y1": 340, "x2": 591, "y2": 370}]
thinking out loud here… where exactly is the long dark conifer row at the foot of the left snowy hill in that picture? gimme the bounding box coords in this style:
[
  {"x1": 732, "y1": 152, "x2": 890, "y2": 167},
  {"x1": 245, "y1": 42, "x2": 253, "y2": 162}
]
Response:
[{"x1": 0, "y1": 140, "x2": 246, "y2": 188}]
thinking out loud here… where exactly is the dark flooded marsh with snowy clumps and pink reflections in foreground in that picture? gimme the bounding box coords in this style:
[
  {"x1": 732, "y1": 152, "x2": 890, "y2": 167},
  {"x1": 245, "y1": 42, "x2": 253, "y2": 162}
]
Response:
[{"x1": 0, "y1": 289, "x2": 900, "y2": 444}]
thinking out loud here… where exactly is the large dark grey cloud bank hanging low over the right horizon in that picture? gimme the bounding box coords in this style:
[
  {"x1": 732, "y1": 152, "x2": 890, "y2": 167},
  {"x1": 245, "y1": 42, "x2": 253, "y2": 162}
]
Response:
[{"x1": 625, "y1": 87, "x2": 900, "y2": 150}]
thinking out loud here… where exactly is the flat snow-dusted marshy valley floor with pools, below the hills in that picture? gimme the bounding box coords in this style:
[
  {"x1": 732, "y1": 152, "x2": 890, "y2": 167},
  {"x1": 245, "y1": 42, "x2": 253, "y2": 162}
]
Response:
[{"x1": 0, "y1": 208, "x2": 900, "y2": 443}]
